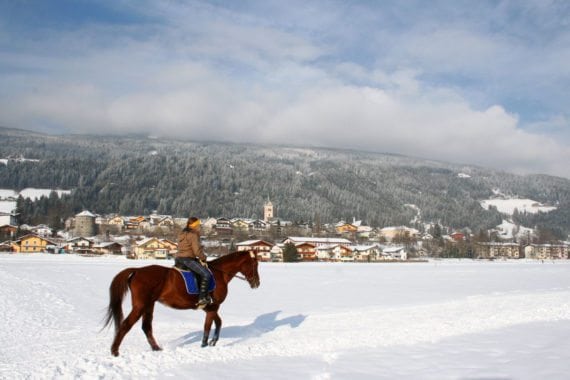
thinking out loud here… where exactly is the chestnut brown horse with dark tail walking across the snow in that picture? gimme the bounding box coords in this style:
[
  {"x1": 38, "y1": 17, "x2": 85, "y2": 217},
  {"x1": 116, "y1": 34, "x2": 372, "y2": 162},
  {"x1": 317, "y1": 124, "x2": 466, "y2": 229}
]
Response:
[{"x1": 103, "y1": 251, "x2": 260, "y2": 356}]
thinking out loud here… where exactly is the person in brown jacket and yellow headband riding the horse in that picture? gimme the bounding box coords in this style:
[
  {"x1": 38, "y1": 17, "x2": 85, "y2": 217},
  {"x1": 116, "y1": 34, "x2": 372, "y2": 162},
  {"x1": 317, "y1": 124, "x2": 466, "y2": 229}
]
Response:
[{"x1": 174, "y1": 217, "x2": 212, "y2": 307}]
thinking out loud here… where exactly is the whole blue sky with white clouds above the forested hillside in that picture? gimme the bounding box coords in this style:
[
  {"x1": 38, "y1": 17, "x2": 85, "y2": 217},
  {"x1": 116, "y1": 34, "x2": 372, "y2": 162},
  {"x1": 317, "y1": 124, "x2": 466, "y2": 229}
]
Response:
[{"x1": 0, "y1": 0, "x2": 570, "y2": 178}]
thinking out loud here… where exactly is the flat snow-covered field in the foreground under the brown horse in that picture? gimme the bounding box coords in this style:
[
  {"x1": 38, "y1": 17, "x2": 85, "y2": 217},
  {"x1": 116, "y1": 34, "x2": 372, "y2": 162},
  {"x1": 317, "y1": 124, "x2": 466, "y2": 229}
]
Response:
[{"x1": 0, "y1": 254, "x2": 570, "y2": 379}]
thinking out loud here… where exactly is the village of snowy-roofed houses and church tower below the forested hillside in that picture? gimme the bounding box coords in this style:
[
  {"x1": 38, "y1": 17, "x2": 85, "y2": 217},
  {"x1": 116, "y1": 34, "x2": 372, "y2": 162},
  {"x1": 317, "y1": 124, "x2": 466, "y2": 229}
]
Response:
[{"x1": 0, "y1": 201, "x2": 568, "y2": 262}]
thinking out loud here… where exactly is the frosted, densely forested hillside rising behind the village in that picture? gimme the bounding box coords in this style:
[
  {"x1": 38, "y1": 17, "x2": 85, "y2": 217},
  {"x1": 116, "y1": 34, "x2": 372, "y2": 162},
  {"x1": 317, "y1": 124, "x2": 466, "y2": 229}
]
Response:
[{"x1": 0, "y1": 128, "x2": 570, "y2": 236}]
